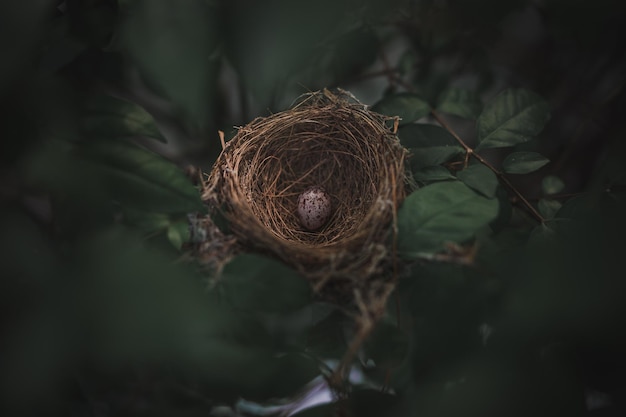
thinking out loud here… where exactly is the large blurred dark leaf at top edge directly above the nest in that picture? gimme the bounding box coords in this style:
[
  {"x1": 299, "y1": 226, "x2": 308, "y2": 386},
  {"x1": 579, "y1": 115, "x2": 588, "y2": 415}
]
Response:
[{"x1": 219, "y1": 0, "x2": 348, "y2": 110}]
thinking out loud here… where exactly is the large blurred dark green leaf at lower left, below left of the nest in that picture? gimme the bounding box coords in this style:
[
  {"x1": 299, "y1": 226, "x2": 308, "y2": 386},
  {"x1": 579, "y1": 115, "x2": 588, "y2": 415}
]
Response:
[{"x1": 76, "y1": 229, "x2": 221, "y2": 352}]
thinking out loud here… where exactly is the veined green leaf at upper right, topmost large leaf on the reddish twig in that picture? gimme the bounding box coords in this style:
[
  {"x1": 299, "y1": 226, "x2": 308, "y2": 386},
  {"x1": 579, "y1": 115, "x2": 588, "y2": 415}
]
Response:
[{"x1": 476, "y1": 89, "x2": 550, "y2": 149}]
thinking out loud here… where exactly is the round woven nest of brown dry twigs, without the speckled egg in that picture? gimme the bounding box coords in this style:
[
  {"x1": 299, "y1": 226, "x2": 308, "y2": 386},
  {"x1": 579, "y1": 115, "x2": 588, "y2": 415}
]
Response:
[{"x1": 203, "y1": 90, "x2": 407, "y2": 300}]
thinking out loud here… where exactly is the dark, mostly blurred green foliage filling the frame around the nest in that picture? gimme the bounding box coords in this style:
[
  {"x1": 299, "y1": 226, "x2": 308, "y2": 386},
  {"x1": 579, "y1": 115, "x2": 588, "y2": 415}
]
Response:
[{"x1": 0, "y1": 0, "x2": 626, "y2": 416}]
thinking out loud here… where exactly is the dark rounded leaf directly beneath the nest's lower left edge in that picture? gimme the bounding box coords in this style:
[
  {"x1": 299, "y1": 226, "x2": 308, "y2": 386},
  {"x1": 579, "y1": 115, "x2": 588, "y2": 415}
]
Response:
[{"x1": 219, "y1": 254, "x2": 311, "y2": 313}]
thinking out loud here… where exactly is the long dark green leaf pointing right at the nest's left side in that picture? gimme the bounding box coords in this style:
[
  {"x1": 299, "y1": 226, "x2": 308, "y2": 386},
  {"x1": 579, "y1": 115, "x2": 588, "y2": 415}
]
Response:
[{"x1": 74, "y1": 141, "x2": 204, "y2": 213}]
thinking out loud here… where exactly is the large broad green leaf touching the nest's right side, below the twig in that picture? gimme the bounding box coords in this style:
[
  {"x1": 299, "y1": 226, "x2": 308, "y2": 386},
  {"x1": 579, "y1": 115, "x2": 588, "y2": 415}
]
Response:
[{"x1": 398, "y1": 181, "x2": 498, "y2": 255}]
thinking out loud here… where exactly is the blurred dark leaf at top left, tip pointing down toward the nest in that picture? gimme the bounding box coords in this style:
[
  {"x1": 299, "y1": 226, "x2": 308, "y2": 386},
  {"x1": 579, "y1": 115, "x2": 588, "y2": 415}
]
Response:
[{"x1": 119, "y1": 0, "x2": 218, "y2": 127}]
